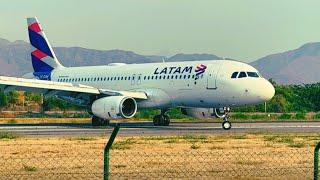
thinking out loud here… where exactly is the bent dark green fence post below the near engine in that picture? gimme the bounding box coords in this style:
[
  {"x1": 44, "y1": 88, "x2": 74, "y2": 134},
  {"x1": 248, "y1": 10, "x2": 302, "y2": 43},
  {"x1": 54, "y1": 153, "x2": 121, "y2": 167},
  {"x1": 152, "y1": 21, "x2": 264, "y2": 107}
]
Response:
[{"x1": 103, "y1": 124, "x2": 120, "y2": 180}]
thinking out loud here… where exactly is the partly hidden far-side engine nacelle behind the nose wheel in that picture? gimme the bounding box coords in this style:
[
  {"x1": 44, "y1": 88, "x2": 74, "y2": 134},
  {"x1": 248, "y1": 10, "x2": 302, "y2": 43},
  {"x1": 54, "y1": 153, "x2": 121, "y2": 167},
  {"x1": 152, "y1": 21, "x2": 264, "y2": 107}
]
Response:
[{"x1": 181, "y1": 108, "x2": 225, "y2": 119}]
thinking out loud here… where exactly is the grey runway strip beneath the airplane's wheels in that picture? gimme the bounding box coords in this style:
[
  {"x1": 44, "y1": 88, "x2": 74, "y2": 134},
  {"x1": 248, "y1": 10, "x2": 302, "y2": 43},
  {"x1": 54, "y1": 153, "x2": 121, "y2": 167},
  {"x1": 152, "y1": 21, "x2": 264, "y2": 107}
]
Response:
[{"x1": 0, "y1": 122, "x2": 320, "y2": 137}]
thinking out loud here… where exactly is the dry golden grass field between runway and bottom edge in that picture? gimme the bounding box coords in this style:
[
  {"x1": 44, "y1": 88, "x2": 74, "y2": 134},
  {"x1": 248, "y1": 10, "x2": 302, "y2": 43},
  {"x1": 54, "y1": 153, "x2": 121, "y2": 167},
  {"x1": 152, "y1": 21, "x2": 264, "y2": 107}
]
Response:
[{"x1": 0, "y1": 130, "x2": 317, "y2": 179}]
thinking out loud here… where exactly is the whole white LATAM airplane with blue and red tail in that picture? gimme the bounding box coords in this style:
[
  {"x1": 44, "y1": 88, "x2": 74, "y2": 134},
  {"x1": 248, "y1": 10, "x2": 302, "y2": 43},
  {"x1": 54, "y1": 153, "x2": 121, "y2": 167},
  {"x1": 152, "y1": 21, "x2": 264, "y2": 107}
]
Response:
[{"x1": 0, "y1": 17, "x2": 275, "y2": 130}]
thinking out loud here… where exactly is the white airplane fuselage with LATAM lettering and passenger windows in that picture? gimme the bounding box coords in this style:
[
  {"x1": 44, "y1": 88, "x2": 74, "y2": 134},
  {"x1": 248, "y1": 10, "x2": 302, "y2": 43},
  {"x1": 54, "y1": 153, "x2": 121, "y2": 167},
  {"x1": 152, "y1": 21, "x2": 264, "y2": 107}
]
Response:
[{"x1": 51, "y1": 60, "x2": 274, "y2": 108}]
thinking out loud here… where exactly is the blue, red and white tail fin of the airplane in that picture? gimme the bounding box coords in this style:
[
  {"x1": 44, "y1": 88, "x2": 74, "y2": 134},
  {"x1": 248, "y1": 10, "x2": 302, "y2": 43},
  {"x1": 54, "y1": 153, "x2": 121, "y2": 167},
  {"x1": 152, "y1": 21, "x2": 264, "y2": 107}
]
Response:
[{"x1": 27, "y1": 17, "x2": 63, "y2": 75}]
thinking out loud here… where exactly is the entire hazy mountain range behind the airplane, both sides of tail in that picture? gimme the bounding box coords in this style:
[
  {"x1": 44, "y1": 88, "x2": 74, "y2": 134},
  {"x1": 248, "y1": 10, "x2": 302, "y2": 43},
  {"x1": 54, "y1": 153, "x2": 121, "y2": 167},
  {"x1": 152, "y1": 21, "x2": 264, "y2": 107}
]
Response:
[{"x1": 0, "y1": 38, "x2": 320, "y2": 84}]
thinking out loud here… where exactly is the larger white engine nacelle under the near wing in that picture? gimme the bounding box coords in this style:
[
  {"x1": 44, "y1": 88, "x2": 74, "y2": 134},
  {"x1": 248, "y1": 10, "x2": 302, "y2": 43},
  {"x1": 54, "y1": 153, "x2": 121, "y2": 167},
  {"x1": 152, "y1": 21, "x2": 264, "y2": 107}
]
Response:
[{"x1": 91, "y1": 96, "x2": 137, "y2": 119}]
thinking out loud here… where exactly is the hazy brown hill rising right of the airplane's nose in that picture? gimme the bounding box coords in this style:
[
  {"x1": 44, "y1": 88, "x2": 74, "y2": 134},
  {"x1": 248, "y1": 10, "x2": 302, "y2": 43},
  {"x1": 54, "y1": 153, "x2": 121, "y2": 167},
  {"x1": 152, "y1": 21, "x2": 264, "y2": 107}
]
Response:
[{"x1": 251, "y1": 42, "x2": 320, "y2": 84}]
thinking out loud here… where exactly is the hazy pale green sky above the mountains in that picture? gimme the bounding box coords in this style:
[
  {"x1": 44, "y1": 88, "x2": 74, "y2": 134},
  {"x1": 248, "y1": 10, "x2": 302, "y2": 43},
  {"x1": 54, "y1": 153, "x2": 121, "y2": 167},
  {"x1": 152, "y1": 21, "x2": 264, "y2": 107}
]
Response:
[{"x1": 0, "y1": 0, "x2": 320, "y2": 62}]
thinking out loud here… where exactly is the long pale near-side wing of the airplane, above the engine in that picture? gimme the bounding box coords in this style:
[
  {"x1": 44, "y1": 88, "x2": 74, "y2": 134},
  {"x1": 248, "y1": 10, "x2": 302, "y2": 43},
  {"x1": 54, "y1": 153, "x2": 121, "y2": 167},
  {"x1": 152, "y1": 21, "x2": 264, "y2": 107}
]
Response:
[{"x1": 0, "y1": 76, "x2": 147, "y2": 100}]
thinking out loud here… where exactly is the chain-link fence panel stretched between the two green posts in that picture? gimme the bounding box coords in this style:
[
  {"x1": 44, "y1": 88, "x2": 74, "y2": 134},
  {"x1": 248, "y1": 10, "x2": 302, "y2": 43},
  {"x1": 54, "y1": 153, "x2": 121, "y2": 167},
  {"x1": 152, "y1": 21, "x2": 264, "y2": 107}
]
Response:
[{"x1": 110, "y1": 150, "x2": 313, "y2": 179}]
